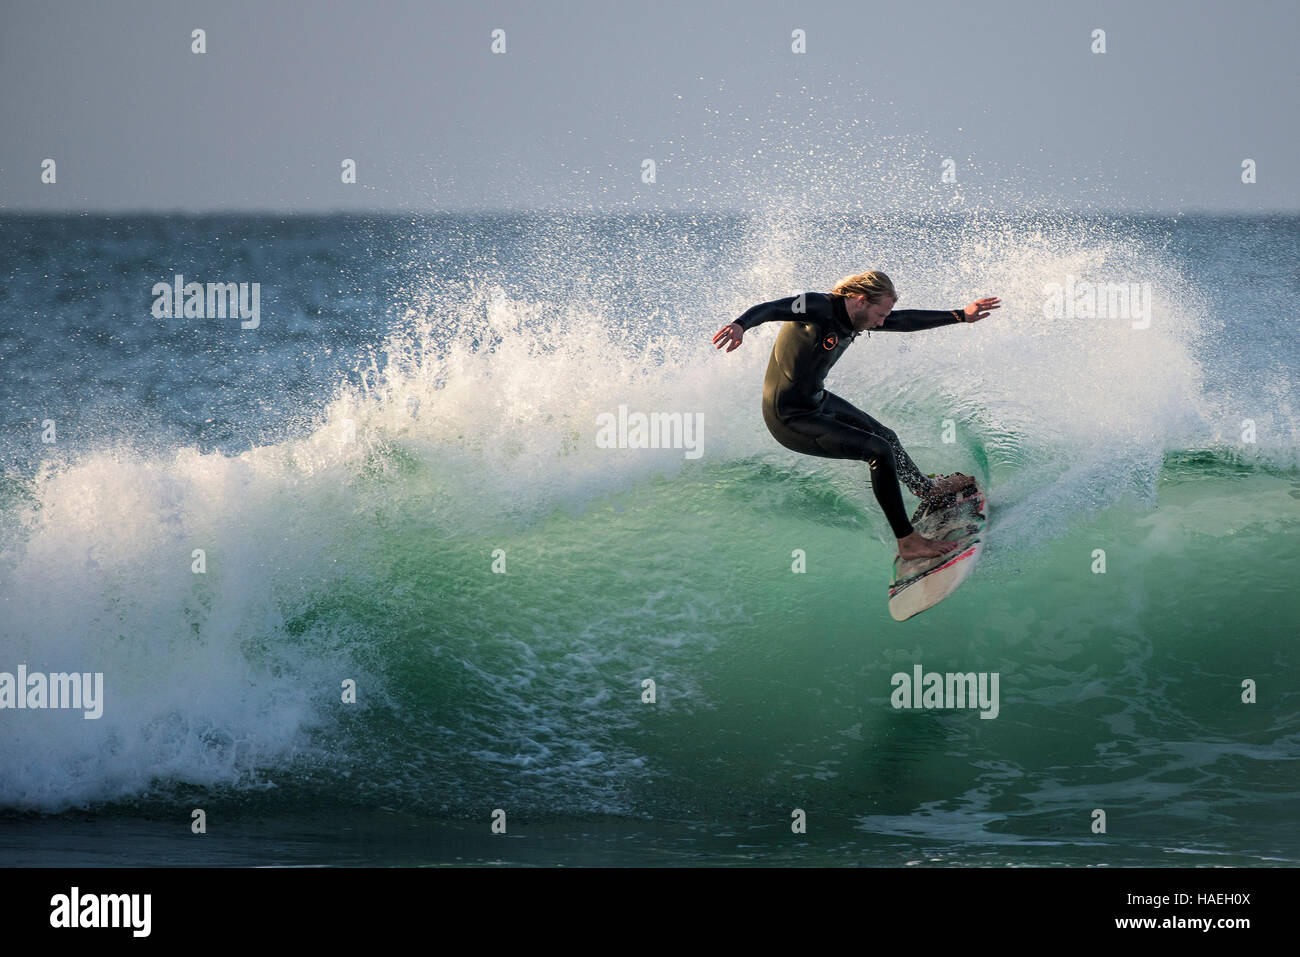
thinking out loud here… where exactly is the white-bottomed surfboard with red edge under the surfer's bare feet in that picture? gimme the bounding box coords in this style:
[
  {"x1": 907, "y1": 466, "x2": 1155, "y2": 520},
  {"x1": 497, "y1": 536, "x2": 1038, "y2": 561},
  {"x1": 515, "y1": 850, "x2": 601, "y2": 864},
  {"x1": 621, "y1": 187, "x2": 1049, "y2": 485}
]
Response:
[{"x1": 889, "y1": 481, "x2": 988, "y2": 622}]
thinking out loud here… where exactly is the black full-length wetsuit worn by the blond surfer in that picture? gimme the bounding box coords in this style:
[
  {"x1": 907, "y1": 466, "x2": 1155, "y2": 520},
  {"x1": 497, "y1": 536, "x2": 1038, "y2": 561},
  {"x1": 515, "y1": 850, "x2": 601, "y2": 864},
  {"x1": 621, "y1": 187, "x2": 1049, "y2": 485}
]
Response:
[{"x1": 736, "y1": 293, "x2": 963, "y2": 538}]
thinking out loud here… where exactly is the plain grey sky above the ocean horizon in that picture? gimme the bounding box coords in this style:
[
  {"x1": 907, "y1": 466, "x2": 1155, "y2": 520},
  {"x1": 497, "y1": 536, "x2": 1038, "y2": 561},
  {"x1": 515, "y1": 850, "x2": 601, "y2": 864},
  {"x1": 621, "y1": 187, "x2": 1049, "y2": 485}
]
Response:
[{"x1": 0, "y1": 0, "x2": 1300, "y2": 212}]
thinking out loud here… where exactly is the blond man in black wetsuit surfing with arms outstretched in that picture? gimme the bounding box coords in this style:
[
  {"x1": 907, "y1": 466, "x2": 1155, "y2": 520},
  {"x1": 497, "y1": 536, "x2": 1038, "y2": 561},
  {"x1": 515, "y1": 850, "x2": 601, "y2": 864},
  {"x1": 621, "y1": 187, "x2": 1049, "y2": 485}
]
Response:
[{"x1": 714, "y1": 270, "x2": 1001, "y2": 559}]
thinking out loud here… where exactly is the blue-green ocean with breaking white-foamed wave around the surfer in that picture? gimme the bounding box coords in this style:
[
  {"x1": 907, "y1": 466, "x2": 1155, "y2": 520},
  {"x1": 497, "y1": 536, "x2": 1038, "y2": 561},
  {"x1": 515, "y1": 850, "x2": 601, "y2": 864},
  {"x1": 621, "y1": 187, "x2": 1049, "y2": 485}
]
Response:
[{"x1": 0, "y1": 213, "x2": 1300, "y2": 866}]
